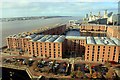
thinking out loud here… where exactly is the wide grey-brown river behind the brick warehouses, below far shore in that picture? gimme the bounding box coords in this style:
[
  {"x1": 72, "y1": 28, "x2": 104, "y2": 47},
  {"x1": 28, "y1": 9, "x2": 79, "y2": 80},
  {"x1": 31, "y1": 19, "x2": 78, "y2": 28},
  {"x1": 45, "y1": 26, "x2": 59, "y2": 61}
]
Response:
[{"x1": 0, "y1": 17, "x2": 81, "y2": 47}]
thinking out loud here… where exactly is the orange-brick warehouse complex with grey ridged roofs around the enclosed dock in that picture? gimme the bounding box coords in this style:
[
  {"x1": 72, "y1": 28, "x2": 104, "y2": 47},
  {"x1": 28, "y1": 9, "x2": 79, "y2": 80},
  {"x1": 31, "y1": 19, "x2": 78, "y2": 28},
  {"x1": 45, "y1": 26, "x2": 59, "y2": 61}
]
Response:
[{"x1": 7, "y1": 24, "x2": 120, "y2": 62}]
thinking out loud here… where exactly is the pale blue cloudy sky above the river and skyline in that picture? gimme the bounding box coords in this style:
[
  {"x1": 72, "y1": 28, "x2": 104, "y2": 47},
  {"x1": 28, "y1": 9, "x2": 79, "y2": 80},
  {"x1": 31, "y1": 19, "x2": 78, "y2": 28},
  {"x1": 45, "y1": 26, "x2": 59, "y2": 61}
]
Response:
[{"x1": 0, "y1": 0, "x2": 118, "y2": 18}]
